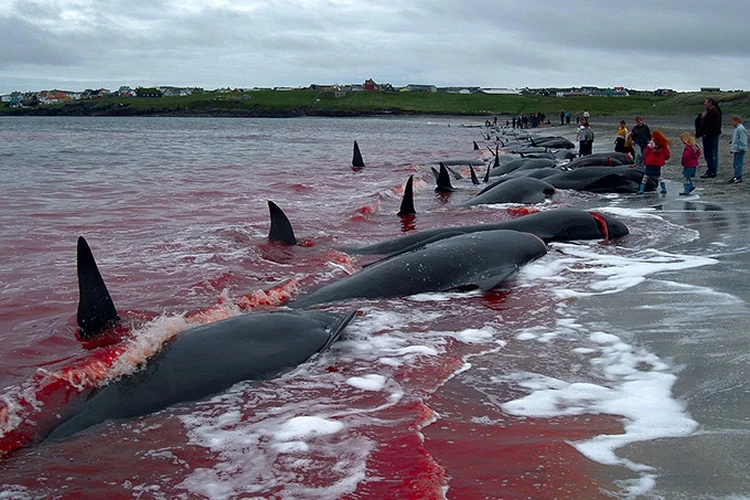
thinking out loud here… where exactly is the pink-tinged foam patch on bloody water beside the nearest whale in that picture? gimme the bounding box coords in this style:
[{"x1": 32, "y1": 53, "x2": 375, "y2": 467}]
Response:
[{"x1": 173, "y1": 308, "x2": 505, "y2": 498}]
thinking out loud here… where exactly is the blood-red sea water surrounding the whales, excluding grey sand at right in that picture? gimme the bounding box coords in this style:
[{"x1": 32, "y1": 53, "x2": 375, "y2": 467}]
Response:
[{"x1": 0, "y1": 118, "x2": 620, "y2": 499}]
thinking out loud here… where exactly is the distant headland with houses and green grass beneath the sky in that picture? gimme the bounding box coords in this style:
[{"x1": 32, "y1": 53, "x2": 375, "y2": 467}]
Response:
[{"x1": 0, "y1": 80, "x2": 750, "y2": 118}]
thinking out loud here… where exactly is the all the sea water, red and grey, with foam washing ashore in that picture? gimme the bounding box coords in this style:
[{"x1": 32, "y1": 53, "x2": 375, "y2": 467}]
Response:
[{"x1": 0, "y1": 117, "x2": 750, "y2": 499}]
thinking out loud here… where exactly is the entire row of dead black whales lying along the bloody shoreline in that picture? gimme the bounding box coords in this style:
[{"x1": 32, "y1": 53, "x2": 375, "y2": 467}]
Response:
[{"x1": 35, "y1": 128, "x2": 640, "y2": 441}]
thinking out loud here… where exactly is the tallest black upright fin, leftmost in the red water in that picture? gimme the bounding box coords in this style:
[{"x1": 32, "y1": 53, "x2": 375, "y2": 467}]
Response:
[{"x1": 76, "y1": 236, "x2": 120, "y2": 339}]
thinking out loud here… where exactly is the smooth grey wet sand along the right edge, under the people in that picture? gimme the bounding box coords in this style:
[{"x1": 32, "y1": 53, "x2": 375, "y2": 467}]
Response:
[{"x1": 545, "y1": 116, "x2": 750, "y2": 498}]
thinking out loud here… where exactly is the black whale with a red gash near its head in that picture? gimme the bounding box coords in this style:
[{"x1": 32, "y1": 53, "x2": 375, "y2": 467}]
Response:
[{"x1": 344, "y1": 208, "x2": 629, "y2": 255}]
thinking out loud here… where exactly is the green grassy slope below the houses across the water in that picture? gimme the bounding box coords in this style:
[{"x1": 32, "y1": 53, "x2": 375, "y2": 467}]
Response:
[{"x1": 0, "y1": 90, "x2": 750, "y2": 121}]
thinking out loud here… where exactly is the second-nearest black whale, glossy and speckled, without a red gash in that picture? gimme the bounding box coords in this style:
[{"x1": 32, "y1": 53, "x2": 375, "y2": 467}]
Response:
[{"x1": 288, "y1": 230, "x2": 547, "y2": 309}]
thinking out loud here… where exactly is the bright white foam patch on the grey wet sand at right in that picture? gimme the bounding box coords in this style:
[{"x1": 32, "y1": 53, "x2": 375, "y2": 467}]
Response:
[{"x1": 494, "y1": 232, "x2": 716, "y2": 496}]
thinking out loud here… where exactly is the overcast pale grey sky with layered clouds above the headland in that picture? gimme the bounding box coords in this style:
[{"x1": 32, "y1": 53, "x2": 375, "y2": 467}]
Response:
[{"x1": 0, "y1": 0, "x2": 750, "y2": 94}]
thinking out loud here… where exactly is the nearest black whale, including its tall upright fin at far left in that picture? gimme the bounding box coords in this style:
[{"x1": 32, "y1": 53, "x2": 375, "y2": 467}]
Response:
[{"x1": 53, "y1": 237, "x2": 354, "y2": 440}]
